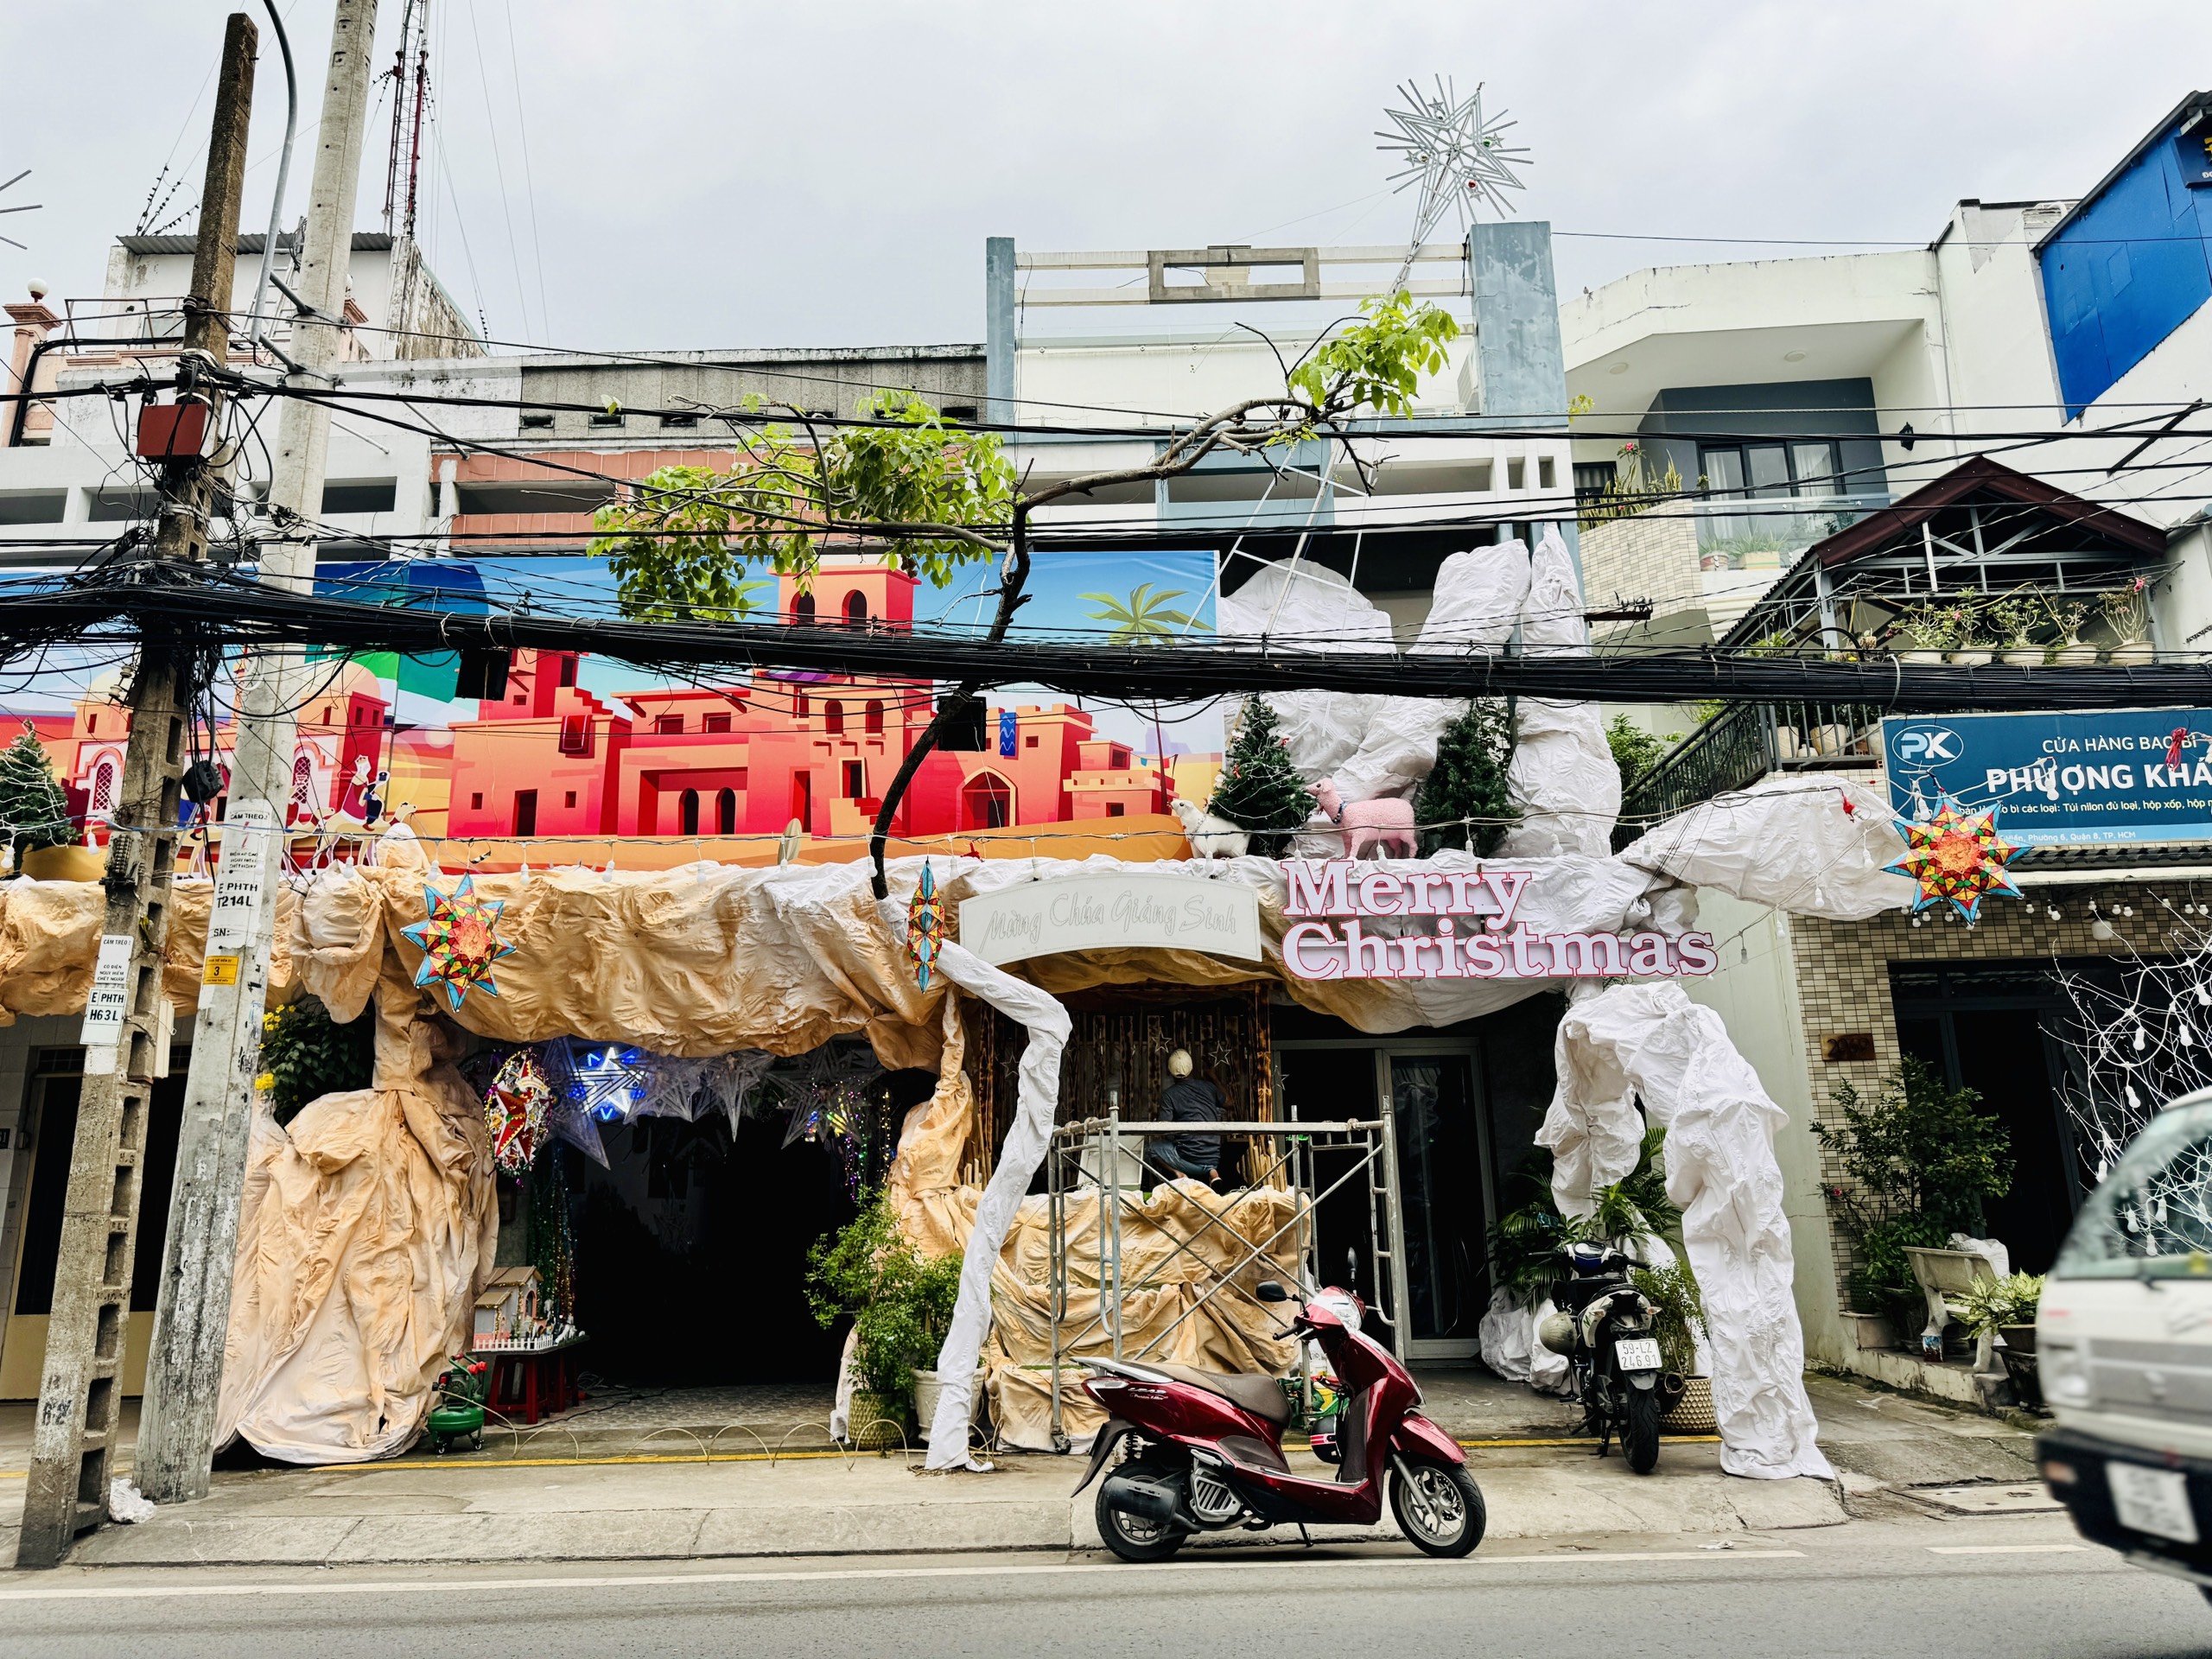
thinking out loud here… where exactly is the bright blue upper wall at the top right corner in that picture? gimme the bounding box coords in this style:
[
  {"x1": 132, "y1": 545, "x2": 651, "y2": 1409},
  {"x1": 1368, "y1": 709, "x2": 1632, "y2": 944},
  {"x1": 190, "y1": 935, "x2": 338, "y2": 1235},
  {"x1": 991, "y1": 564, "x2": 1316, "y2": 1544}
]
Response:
[{"x1": 2037, "y1": 115, "x2": 2212, "y2": 418}]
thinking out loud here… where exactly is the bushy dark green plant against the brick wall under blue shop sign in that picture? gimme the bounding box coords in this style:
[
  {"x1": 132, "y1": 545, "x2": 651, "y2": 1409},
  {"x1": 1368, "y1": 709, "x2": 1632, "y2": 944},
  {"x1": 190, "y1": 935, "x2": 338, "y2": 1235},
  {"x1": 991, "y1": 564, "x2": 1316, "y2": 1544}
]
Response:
[{"x1": 1814, "y1": 1058, "x2": 2013, "y2": 1330}]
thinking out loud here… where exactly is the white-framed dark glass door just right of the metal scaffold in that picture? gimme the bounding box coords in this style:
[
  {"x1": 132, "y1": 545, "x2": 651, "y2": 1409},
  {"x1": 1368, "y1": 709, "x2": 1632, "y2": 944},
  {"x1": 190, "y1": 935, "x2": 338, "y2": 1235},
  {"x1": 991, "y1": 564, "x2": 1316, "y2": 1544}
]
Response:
[{"x1": 1382, "y1": 1051, "x2": 1489, "y2": 1358}]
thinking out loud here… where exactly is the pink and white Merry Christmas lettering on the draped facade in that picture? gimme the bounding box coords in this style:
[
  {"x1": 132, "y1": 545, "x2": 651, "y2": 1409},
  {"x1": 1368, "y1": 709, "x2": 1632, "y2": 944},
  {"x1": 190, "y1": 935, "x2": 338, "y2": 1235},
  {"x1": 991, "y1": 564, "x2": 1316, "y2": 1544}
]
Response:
[{"x1": 1283, "y1": 858, "x2": 1719, "y2": 980}]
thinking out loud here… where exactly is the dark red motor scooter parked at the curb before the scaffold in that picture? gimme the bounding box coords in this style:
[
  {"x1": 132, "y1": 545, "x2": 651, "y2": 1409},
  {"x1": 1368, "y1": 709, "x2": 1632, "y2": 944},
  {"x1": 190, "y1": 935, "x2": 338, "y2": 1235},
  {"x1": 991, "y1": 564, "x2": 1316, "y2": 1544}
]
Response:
[{"x1": 1075, "y1": 1279, "x2": 1486, "y2": 1561}]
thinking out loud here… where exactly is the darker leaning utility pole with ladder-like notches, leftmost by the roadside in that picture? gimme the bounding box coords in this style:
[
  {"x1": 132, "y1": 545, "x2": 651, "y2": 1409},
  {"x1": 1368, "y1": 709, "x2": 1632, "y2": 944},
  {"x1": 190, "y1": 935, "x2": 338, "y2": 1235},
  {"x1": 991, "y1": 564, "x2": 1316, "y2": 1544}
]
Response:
[{"x1": 16, "y1": 13, "x2": 259, "y2": 1566}]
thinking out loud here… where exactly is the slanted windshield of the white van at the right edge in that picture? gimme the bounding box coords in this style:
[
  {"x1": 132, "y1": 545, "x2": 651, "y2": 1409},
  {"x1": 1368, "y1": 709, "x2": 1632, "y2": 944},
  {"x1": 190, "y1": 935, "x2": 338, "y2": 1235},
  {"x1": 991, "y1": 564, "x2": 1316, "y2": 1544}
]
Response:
[{"x1": 2050, "y1": 1103, "x2": 2212, "y2": 1279}]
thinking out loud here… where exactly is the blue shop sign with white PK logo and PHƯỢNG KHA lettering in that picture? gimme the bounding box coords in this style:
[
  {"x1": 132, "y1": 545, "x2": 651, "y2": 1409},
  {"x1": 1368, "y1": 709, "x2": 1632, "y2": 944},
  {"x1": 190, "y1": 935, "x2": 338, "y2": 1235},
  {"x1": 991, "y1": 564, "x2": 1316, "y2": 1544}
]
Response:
[{"x1": 1883, "y1": 708, "x2": 2212, "y2": 847}]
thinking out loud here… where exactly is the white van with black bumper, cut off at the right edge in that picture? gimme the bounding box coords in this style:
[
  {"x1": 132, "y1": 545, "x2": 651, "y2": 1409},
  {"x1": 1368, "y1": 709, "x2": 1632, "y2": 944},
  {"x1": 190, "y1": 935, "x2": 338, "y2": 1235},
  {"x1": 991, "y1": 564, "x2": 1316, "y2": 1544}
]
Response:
[{"x1": 2035, "y1": 1090, "x2": 2212, "y2": 1599}]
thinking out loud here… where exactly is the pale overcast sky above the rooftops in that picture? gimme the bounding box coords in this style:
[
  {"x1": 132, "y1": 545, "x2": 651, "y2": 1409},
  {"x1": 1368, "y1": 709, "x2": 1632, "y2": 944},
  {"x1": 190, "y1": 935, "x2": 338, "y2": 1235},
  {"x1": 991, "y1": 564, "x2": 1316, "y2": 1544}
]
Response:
[{"x1": 0, "y1": 0, "x2": 2212, "y2": 347}]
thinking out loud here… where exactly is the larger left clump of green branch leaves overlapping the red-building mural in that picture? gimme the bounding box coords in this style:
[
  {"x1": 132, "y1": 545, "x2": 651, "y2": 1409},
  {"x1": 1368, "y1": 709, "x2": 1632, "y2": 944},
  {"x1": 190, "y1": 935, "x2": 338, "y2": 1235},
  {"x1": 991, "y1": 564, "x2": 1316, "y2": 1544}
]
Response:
[{"x1": 588, "y1": 391, "x2": 1013, "y2": 621}]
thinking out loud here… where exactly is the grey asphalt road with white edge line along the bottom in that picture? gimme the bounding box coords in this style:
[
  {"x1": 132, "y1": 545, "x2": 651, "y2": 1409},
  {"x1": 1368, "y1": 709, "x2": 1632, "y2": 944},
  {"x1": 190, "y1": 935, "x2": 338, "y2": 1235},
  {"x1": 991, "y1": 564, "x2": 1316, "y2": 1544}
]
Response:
[{"x1": 0, "y1": 1522, "x2": 2212, "y2": 1659}]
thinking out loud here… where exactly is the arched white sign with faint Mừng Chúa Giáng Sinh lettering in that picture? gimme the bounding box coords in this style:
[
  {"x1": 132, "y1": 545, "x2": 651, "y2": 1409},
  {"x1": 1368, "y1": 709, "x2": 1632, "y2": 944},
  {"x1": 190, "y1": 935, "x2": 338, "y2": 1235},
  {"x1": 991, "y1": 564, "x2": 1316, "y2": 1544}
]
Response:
[{"x1": 960, "y1": 872, "x2": 1259, "y2": 963}]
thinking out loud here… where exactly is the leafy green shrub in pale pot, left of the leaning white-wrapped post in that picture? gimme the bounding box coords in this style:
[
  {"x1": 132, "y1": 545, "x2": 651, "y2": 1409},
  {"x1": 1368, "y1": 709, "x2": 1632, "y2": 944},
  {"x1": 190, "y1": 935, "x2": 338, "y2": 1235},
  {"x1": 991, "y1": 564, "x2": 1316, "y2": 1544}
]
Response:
[{"x1": 807, "y1": 1192, "x2": 960, "y2": 1451}]
